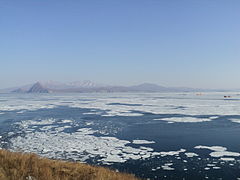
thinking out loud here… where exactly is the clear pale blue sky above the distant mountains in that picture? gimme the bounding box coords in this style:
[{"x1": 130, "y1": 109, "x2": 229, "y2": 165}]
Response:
[{"x1": 0, "y1": 0, "x2": 240, "y2": 89}]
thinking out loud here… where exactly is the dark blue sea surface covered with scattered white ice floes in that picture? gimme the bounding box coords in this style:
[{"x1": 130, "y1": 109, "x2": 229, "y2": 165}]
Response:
[{"x1": 0, "y1": 92, "x2": 240, "y2": 180}]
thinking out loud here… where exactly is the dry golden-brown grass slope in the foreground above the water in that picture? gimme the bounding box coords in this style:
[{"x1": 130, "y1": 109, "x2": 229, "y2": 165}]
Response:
[{"x1": 0, "y1": 150, "x2": 137, "y2": 180}]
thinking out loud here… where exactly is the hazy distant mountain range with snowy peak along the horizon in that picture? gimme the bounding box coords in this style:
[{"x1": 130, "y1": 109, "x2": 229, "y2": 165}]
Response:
[{"x1": 0, "y1": 81, "x2": 219, "y2": 93}]
